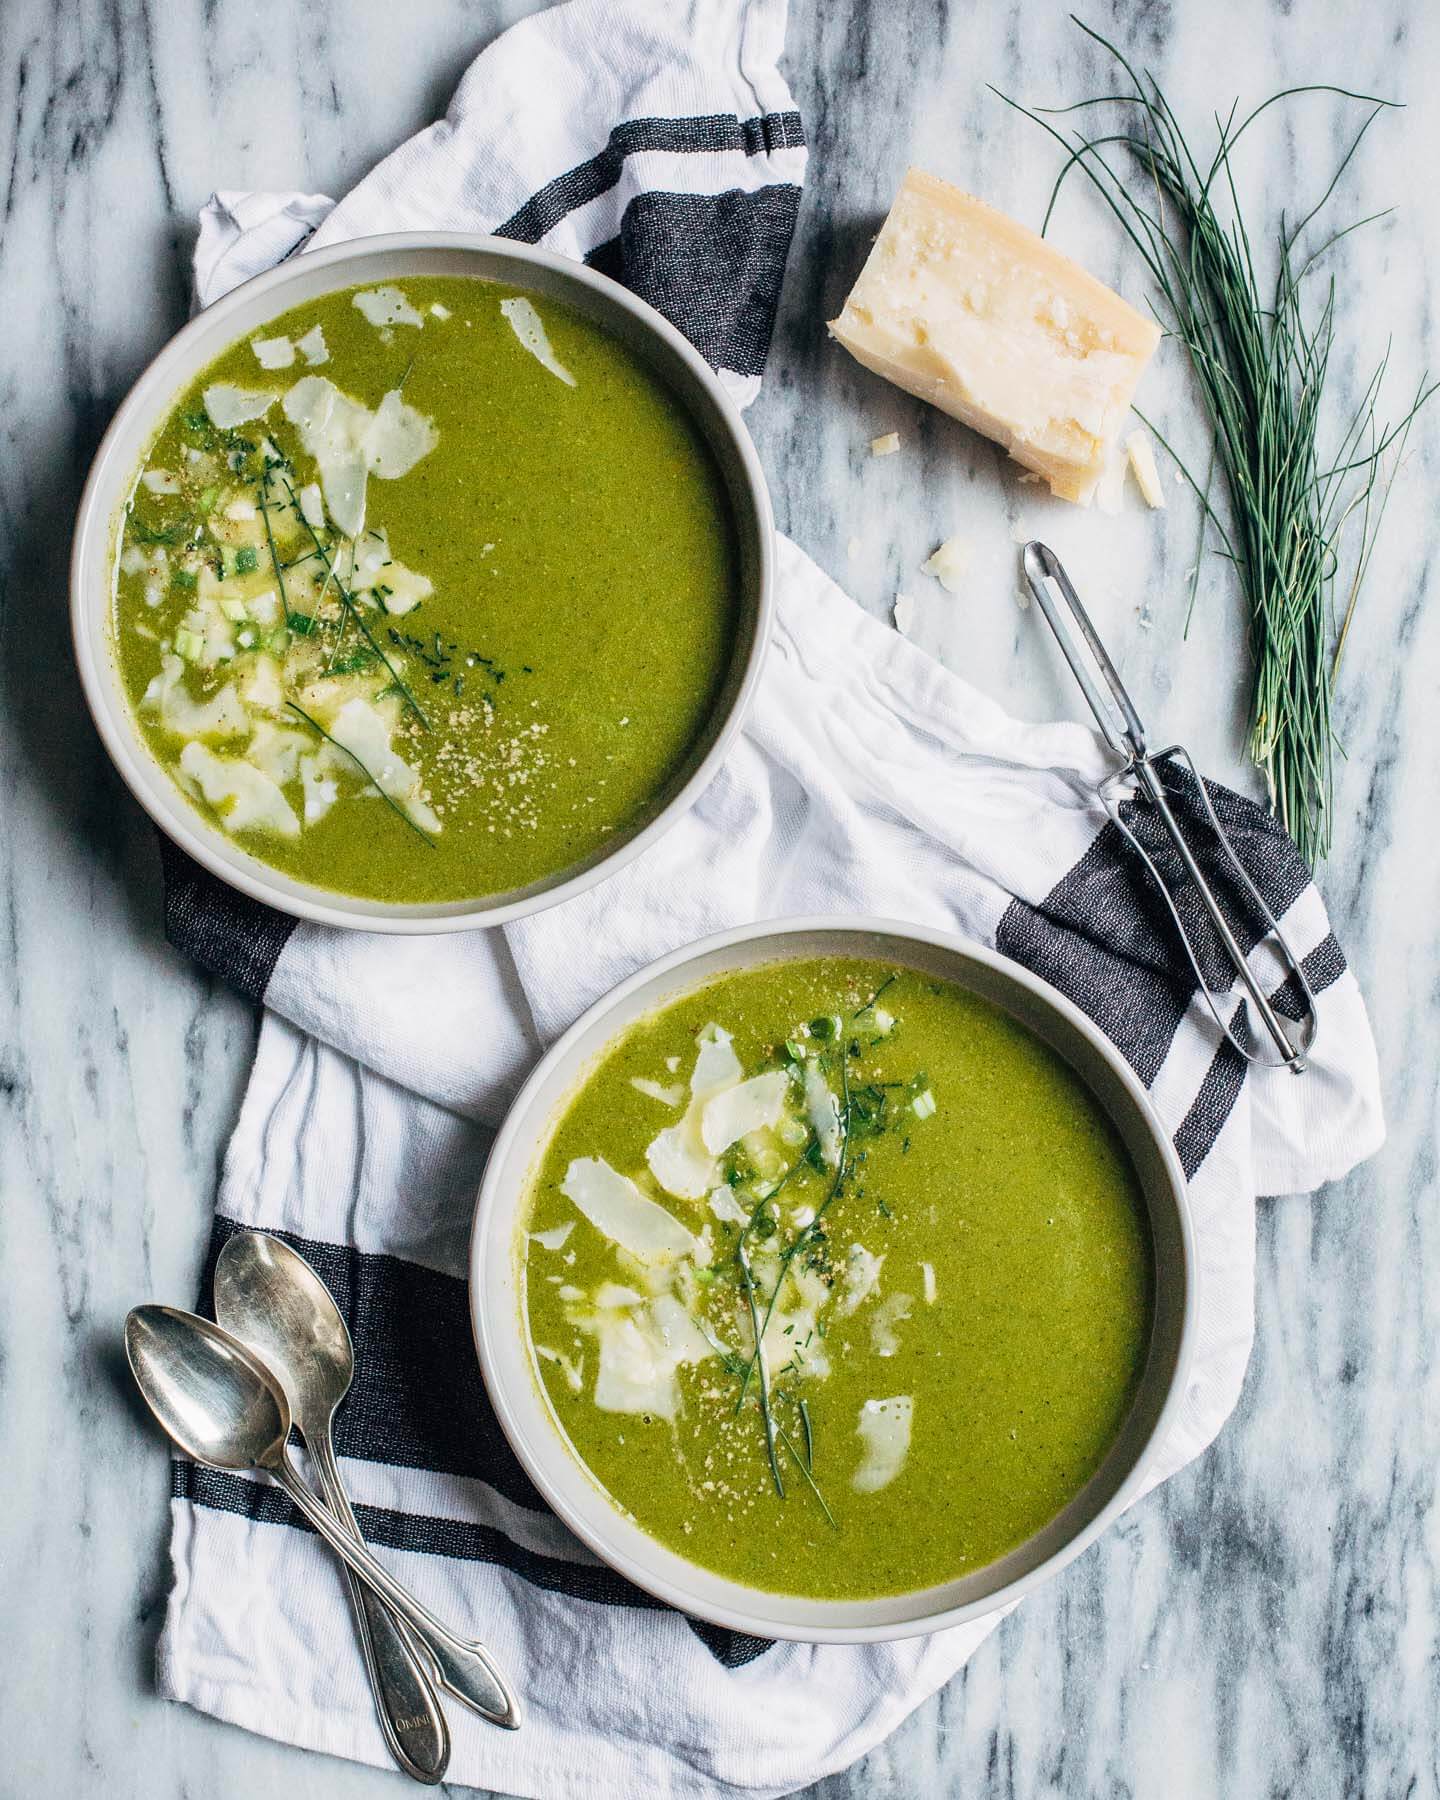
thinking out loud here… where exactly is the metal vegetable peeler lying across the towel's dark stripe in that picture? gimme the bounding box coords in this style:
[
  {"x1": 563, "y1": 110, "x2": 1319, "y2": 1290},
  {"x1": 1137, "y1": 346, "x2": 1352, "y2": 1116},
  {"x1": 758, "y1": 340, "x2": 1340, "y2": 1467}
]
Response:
[{"x1": 1024, "y1": 542, "x2": 1319, "y2": 1075}]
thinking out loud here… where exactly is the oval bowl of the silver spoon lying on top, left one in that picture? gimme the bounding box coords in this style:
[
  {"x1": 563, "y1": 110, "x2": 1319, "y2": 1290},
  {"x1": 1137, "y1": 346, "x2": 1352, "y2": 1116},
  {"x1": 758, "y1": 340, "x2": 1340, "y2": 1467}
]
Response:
[{"x1": 124, "y1": 1305, "x2": 290, "y2": 1471}]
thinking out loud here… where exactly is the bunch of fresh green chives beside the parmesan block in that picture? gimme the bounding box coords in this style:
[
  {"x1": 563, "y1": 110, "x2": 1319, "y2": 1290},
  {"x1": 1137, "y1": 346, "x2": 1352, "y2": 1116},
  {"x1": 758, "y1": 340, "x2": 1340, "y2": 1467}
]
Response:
[{"x1": 1001, "y1": 20, "x2": 1436, "y2": 864}]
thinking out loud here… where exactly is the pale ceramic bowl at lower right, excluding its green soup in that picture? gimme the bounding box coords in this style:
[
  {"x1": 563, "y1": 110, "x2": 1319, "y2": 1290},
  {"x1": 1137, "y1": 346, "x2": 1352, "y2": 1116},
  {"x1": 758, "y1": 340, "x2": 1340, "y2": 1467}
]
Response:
[{"x1": 470, "y1": 918, "x2": 1195, "y2": 1643}]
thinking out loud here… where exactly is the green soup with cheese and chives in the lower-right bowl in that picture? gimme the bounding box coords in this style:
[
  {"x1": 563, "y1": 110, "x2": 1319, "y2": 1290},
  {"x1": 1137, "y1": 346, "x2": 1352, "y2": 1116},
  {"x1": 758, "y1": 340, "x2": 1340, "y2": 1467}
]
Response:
[{"x1": 517, "y1": 959, "x2": 1152, "y2": 1598}]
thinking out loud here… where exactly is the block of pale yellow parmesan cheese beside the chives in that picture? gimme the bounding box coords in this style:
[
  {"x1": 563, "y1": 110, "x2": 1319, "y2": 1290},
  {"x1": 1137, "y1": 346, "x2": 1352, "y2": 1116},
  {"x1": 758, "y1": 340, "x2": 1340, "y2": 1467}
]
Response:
[{"x1": 830, "y1": 169, "x2": 1159, "y2": 506}]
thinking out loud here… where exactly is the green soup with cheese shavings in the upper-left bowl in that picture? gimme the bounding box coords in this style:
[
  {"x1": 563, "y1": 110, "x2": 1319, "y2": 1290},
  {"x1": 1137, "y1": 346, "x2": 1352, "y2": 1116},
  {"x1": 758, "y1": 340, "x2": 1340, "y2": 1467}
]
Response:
[{"x1": 113, "y1": 277, "x2": 738, "y2": 904}]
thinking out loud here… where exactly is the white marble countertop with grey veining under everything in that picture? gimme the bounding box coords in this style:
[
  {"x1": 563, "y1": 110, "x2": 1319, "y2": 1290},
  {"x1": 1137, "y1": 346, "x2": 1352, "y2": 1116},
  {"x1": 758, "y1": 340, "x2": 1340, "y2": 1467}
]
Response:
[{"x1": 0, "y1": 0, "x2": 1440, "y2": 1800}]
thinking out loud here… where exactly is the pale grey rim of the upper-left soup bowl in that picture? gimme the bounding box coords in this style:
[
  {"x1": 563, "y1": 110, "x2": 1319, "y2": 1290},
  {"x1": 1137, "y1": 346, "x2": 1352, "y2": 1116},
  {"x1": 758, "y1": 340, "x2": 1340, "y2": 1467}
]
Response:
[{"x1": 68, "y1": 232, "x2": 776, "y2": 936}]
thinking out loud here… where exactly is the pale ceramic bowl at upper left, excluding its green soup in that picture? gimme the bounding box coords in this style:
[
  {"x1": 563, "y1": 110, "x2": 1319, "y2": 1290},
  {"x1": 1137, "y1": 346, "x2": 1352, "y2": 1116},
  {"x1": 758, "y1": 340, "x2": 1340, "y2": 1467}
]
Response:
[{"x1": 70, "y1": 232, "x2": 774, "y2": 932}]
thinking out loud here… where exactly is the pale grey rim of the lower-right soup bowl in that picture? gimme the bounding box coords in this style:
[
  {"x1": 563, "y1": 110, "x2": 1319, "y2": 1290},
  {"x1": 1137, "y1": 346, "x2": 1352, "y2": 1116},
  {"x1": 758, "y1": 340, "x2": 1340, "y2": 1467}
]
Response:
[{"x1": 468, "y1": 913, "x2": 1199, "y2": 1643}]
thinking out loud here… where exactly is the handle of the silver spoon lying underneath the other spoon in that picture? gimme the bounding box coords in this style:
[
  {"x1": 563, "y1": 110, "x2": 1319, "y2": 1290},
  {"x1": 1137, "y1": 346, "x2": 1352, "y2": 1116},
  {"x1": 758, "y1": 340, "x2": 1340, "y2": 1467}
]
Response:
[{"x1": 306, "y1": 1427, "x2": 450, "y2": 1787}]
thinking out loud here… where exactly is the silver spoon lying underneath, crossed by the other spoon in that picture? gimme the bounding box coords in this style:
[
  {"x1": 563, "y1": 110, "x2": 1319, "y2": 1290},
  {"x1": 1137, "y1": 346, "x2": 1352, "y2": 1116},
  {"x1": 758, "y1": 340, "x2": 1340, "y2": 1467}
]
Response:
[{"x1": 214, "y1": 1231, "x2": 450, "y2": 1786}]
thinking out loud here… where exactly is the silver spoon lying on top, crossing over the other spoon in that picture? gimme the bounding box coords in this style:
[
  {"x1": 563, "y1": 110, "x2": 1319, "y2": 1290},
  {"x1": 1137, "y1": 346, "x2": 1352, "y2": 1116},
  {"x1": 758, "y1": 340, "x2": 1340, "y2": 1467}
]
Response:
[{"x1": 124, "y1": 1307, "x2": 520, "y2": 1730}]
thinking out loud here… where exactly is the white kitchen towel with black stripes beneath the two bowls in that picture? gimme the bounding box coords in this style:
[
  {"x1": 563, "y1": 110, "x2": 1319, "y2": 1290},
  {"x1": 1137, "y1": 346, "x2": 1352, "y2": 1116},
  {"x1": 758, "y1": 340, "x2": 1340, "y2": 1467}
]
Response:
[{"x1": 160, "y1": 0, "x2": 1382, "y2": 1800}]
